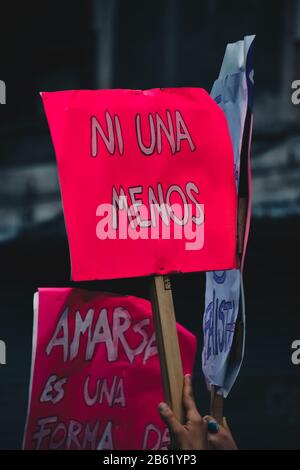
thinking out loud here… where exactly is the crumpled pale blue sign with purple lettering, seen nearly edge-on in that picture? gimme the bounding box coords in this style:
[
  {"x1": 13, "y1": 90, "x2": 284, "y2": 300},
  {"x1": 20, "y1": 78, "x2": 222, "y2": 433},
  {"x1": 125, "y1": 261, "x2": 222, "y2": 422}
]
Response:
[{"x1": 202, "y1": 36, "x2": 255, "y2": 397}]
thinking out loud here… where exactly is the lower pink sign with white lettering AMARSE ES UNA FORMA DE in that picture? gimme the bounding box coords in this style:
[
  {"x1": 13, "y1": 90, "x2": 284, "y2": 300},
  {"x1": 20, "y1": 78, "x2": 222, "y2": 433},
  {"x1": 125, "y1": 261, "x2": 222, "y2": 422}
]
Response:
[{"x1": 24, "y1": 288, "x2": 196, "y2": 449}]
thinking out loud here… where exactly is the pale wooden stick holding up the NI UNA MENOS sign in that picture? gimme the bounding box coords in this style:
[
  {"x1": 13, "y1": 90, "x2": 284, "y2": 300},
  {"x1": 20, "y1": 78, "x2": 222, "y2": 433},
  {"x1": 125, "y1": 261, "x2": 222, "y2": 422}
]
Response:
[{"x1": 151, "y1": 276, "x2": 184, "y2": 423}]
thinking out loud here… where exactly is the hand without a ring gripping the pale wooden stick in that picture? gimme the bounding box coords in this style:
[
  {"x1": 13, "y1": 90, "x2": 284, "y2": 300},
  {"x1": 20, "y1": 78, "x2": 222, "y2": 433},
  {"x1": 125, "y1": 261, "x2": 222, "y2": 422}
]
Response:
[{"x1": 158, "y1": 375, "x2": 209, "y2": 450}]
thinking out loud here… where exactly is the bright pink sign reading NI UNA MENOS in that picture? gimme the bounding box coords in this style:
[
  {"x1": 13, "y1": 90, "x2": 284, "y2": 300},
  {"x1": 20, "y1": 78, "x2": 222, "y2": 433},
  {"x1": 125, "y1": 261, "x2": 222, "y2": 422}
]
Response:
[{"x1": 42, "y1": 88, "x2": 237, "y2": 280}]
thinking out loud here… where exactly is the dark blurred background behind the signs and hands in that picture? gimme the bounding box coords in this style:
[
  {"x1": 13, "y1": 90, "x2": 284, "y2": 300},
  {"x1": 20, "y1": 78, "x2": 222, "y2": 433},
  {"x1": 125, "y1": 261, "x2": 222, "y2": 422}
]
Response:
[{"x1": 0, "y1": 0, "x2": 300, "y2": 449}]
